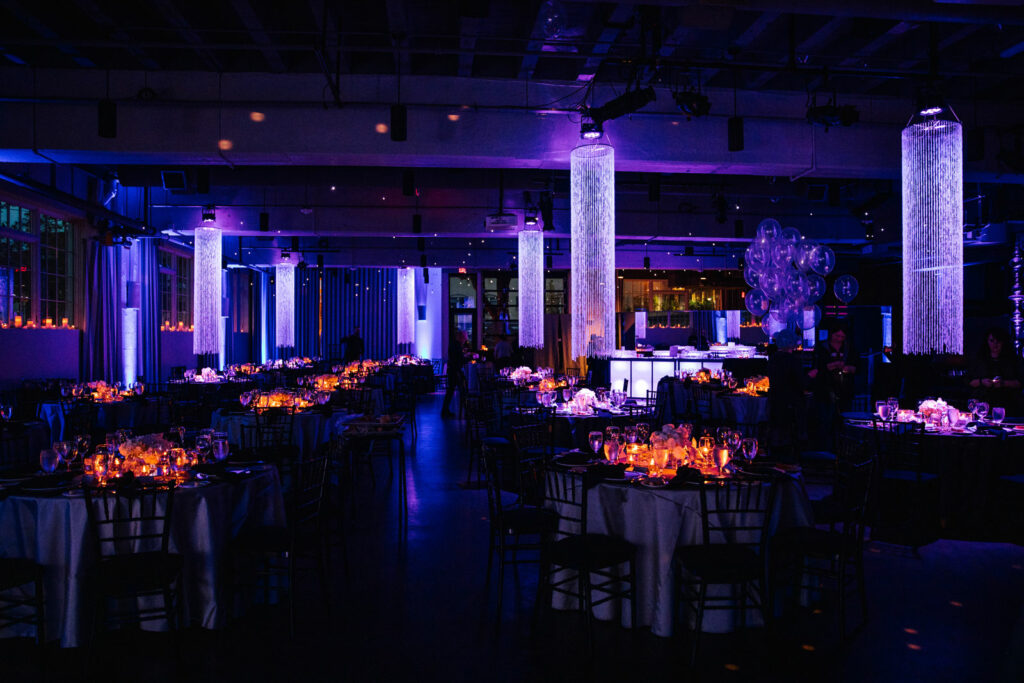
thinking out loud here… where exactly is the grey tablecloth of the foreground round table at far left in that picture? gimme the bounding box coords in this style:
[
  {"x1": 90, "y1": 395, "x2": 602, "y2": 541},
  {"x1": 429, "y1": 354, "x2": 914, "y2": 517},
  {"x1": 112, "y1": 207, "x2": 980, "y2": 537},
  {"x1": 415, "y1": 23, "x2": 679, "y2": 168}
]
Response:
[{"x1": 0, "y1": 466, "x2": 285, "y2": 647}]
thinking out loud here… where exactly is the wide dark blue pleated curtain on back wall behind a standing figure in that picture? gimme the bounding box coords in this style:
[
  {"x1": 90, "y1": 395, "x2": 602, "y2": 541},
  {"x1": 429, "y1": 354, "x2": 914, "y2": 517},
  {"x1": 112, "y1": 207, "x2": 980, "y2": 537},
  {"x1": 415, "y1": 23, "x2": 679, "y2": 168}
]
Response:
[{"x1": 295, "y1": 268, "x2": 398, "y2": 359}]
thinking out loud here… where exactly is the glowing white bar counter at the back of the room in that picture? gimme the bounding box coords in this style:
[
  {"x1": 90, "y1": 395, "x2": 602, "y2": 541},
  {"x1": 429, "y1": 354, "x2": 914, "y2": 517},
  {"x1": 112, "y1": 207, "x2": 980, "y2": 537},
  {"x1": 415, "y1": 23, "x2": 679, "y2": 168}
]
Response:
[{"x1": 608, "y1": 344, "x2": 767, "y2": 398}]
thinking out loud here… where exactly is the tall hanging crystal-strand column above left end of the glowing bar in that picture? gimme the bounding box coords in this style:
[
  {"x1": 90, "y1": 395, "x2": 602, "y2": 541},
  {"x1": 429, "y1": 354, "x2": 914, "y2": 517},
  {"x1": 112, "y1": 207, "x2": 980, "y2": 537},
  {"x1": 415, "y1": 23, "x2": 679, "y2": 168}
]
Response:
[{"x1": 570, "y1": 142, "x2": 615, "y2": 357}]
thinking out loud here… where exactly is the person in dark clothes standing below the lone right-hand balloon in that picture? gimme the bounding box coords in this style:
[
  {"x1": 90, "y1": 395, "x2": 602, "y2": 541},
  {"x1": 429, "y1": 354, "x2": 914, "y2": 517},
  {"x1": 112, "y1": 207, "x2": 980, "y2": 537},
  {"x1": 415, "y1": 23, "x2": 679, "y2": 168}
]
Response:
[{"x1": 807, "y1": 322, "x2": 857, "y2": 451}]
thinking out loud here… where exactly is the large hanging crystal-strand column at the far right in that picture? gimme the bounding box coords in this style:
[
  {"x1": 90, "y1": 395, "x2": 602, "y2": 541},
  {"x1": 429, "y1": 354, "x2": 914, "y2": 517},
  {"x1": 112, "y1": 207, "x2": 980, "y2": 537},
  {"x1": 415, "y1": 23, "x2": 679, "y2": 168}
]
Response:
[{"x1": 903, "y1": 110, "x2": 964, "y2": 353}]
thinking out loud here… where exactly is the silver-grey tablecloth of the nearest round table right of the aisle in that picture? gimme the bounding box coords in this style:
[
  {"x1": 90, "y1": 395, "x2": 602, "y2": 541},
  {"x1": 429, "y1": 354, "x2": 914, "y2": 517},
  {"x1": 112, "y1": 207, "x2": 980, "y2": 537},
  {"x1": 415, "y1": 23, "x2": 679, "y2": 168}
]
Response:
[{"x1": 552, "y1": 474, "x2": 813, "y2": 637}]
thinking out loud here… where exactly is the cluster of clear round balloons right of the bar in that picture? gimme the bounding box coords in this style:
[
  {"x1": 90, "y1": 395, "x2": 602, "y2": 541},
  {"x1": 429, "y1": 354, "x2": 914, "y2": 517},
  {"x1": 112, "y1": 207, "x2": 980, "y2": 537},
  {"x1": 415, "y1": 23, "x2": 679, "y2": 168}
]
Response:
[{"x1": 743, "y1": 218, "x2": 858, "y2": 338}]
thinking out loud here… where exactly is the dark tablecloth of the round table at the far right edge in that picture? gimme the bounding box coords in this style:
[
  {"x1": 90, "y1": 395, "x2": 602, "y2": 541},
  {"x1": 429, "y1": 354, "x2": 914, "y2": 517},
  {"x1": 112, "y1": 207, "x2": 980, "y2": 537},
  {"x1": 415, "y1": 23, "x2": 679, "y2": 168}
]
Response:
[{"x1": 846, "y1": 419, "x2": 1024, "y2": 529}]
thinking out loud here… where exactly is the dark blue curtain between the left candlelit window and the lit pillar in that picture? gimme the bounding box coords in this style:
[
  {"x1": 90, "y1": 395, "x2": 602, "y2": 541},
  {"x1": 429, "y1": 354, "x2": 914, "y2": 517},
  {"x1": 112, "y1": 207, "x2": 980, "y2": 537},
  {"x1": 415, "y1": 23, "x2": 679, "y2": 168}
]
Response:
[{"x1": 82, "y1": 242, "x2": 124, "y2": 383}]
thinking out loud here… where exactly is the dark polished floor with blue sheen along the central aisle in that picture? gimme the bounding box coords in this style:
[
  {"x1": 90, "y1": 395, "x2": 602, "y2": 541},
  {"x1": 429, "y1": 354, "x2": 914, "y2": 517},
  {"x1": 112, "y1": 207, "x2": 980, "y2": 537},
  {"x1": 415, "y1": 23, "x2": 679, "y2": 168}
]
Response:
[{"x1": 0, "y1": 395, "x2": 1024, "y2": 682}]
